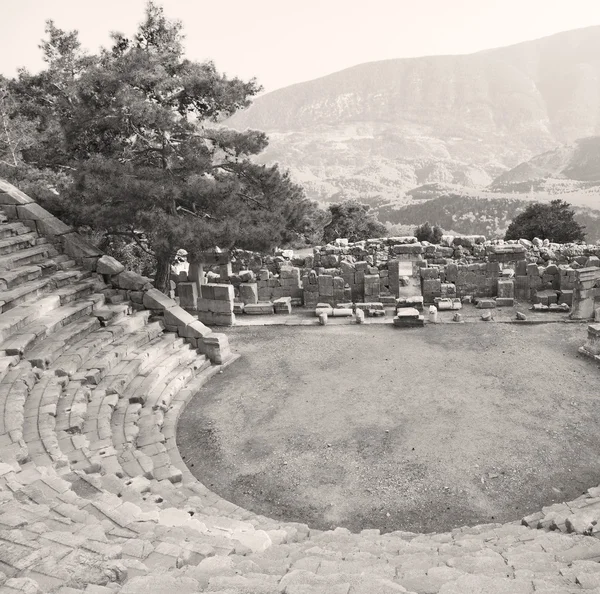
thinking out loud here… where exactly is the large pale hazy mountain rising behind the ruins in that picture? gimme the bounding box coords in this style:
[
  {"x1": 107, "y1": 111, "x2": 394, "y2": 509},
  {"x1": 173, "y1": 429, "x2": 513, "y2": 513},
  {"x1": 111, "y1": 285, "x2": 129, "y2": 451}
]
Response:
[{"x1": 228, "y1": 26, "x2": 600, "y2": 204}]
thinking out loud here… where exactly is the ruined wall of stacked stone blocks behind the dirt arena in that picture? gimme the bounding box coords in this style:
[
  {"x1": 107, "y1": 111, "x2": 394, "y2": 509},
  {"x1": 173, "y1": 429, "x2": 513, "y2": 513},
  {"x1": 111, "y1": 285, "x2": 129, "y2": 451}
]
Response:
[{"x1": 176, "y1": 236, "x2": 600, "y2": 325}]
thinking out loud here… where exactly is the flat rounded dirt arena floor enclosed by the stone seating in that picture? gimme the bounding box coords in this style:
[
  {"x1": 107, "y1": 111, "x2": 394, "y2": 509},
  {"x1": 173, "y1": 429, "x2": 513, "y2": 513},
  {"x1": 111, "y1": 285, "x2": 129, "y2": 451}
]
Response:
[{"x1": 178, "y1": 323, "x2": 600, "y2": 532}]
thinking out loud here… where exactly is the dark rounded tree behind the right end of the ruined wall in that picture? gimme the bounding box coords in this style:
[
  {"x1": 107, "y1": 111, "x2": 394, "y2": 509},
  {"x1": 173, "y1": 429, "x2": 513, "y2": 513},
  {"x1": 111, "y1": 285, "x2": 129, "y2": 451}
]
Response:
[{"x1": 504, "y1": 199, "x2": 585, "y2": 243}]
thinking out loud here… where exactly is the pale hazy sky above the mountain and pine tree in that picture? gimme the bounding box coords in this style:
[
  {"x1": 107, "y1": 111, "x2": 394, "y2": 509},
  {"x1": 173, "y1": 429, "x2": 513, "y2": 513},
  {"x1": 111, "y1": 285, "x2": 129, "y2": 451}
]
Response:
[{"x1": 0, "y1": 0, "x2": 600, "y2": 91}]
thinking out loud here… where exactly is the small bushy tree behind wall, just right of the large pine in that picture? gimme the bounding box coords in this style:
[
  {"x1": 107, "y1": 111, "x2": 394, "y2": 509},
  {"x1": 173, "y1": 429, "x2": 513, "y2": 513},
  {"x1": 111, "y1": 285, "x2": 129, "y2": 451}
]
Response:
[{"x1": 323, "y1": 200, "x2": 386, "y2": 243}]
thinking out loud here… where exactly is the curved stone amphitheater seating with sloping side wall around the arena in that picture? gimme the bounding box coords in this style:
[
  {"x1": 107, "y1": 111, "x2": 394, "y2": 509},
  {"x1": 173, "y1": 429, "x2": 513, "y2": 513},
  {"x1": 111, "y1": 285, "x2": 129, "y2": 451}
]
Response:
[{"x1": 0, "y1": 177, "x2": 600, "y2": 594}]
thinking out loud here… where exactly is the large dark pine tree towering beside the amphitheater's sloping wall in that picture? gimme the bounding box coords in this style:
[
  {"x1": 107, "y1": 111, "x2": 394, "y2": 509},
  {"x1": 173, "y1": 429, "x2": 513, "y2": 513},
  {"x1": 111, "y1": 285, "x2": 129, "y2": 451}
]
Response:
[{"x1": 0, "y1": 1, "x2": 324, "y2": 289}]
